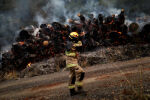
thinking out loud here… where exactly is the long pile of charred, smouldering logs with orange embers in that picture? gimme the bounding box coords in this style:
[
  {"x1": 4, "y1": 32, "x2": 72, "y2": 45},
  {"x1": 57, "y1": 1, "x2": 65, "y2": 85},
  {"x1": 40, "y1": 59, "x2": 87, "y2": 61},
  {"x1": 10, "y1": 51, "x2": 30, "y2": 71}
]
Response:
[{"x1": 1, "y1": 9, "x2": 150, "y2": 76}]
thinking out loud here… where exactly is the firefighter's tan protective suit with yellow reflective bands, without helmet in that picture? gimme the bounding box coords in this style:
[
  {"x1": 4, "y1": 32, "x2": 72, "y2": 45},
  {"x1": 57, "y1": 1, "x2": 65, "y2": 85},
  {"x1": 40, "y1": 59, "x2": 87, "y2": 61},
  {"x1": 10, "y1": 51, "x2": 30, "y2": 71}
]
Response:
[{"x1": 65, "y1": 41, "x2": 85, "y2": 90}]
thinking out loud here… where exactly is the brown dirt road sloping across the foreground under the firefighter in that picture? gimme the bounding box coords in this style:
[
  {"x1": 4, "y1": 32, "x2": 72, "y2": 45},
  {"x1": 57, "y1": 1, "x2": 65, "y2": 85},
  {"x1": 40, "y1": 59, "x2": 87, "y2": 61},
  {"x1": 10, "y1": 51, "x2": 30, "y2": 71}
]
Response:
[{"x1": 0, "y1": 57, "x2": 150, "y2": 100}]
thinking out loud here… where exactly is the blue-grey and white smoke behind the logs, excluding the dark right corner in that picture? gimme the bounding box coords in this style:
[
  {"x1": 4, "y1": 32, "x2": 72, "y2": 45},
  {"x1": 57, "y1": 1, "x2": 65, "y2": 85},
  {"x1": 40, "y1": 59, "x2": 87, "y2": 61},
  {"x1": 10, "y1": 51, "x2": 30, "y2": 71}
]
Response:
[{"x1": 0, "y1": 0, "x2": 123, "y2": 50}]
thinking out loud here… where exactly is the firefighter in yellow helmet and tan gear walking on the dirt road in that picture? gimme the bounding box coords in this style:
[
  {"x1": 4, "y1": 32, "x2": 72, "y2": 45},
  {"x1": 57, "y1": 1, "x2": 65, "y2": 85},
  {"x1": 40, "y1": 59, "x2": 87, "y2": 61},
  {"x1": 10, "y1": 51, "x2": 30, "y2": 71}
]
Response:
[{"x1": 65, "y1": 32, "x2": 85, "y2": 96}]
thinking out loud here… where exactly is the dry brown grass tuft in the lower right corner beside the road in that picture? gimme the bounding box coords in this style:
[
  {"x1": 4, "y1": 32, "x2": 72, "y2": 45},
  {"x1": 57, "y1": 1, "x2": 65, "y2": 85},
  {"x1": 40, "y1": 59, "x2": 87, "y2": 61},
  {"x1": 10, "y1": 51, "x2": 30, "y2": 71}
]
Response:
[{"x1": 114, "y1": 66, "x2": 150, "y2": 100}]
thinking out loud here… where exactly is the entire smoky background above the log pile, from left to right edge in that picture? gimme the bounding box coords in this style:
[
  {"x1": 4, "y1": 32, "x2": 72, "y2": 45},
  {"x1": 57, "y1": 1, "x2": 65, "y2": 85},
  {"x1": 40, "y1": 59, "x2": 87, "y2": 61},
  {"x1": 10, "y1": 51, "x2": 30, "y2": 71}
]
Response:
[{"x1": 0, "y1": 0, "x2": 150, "y2": 51}]
